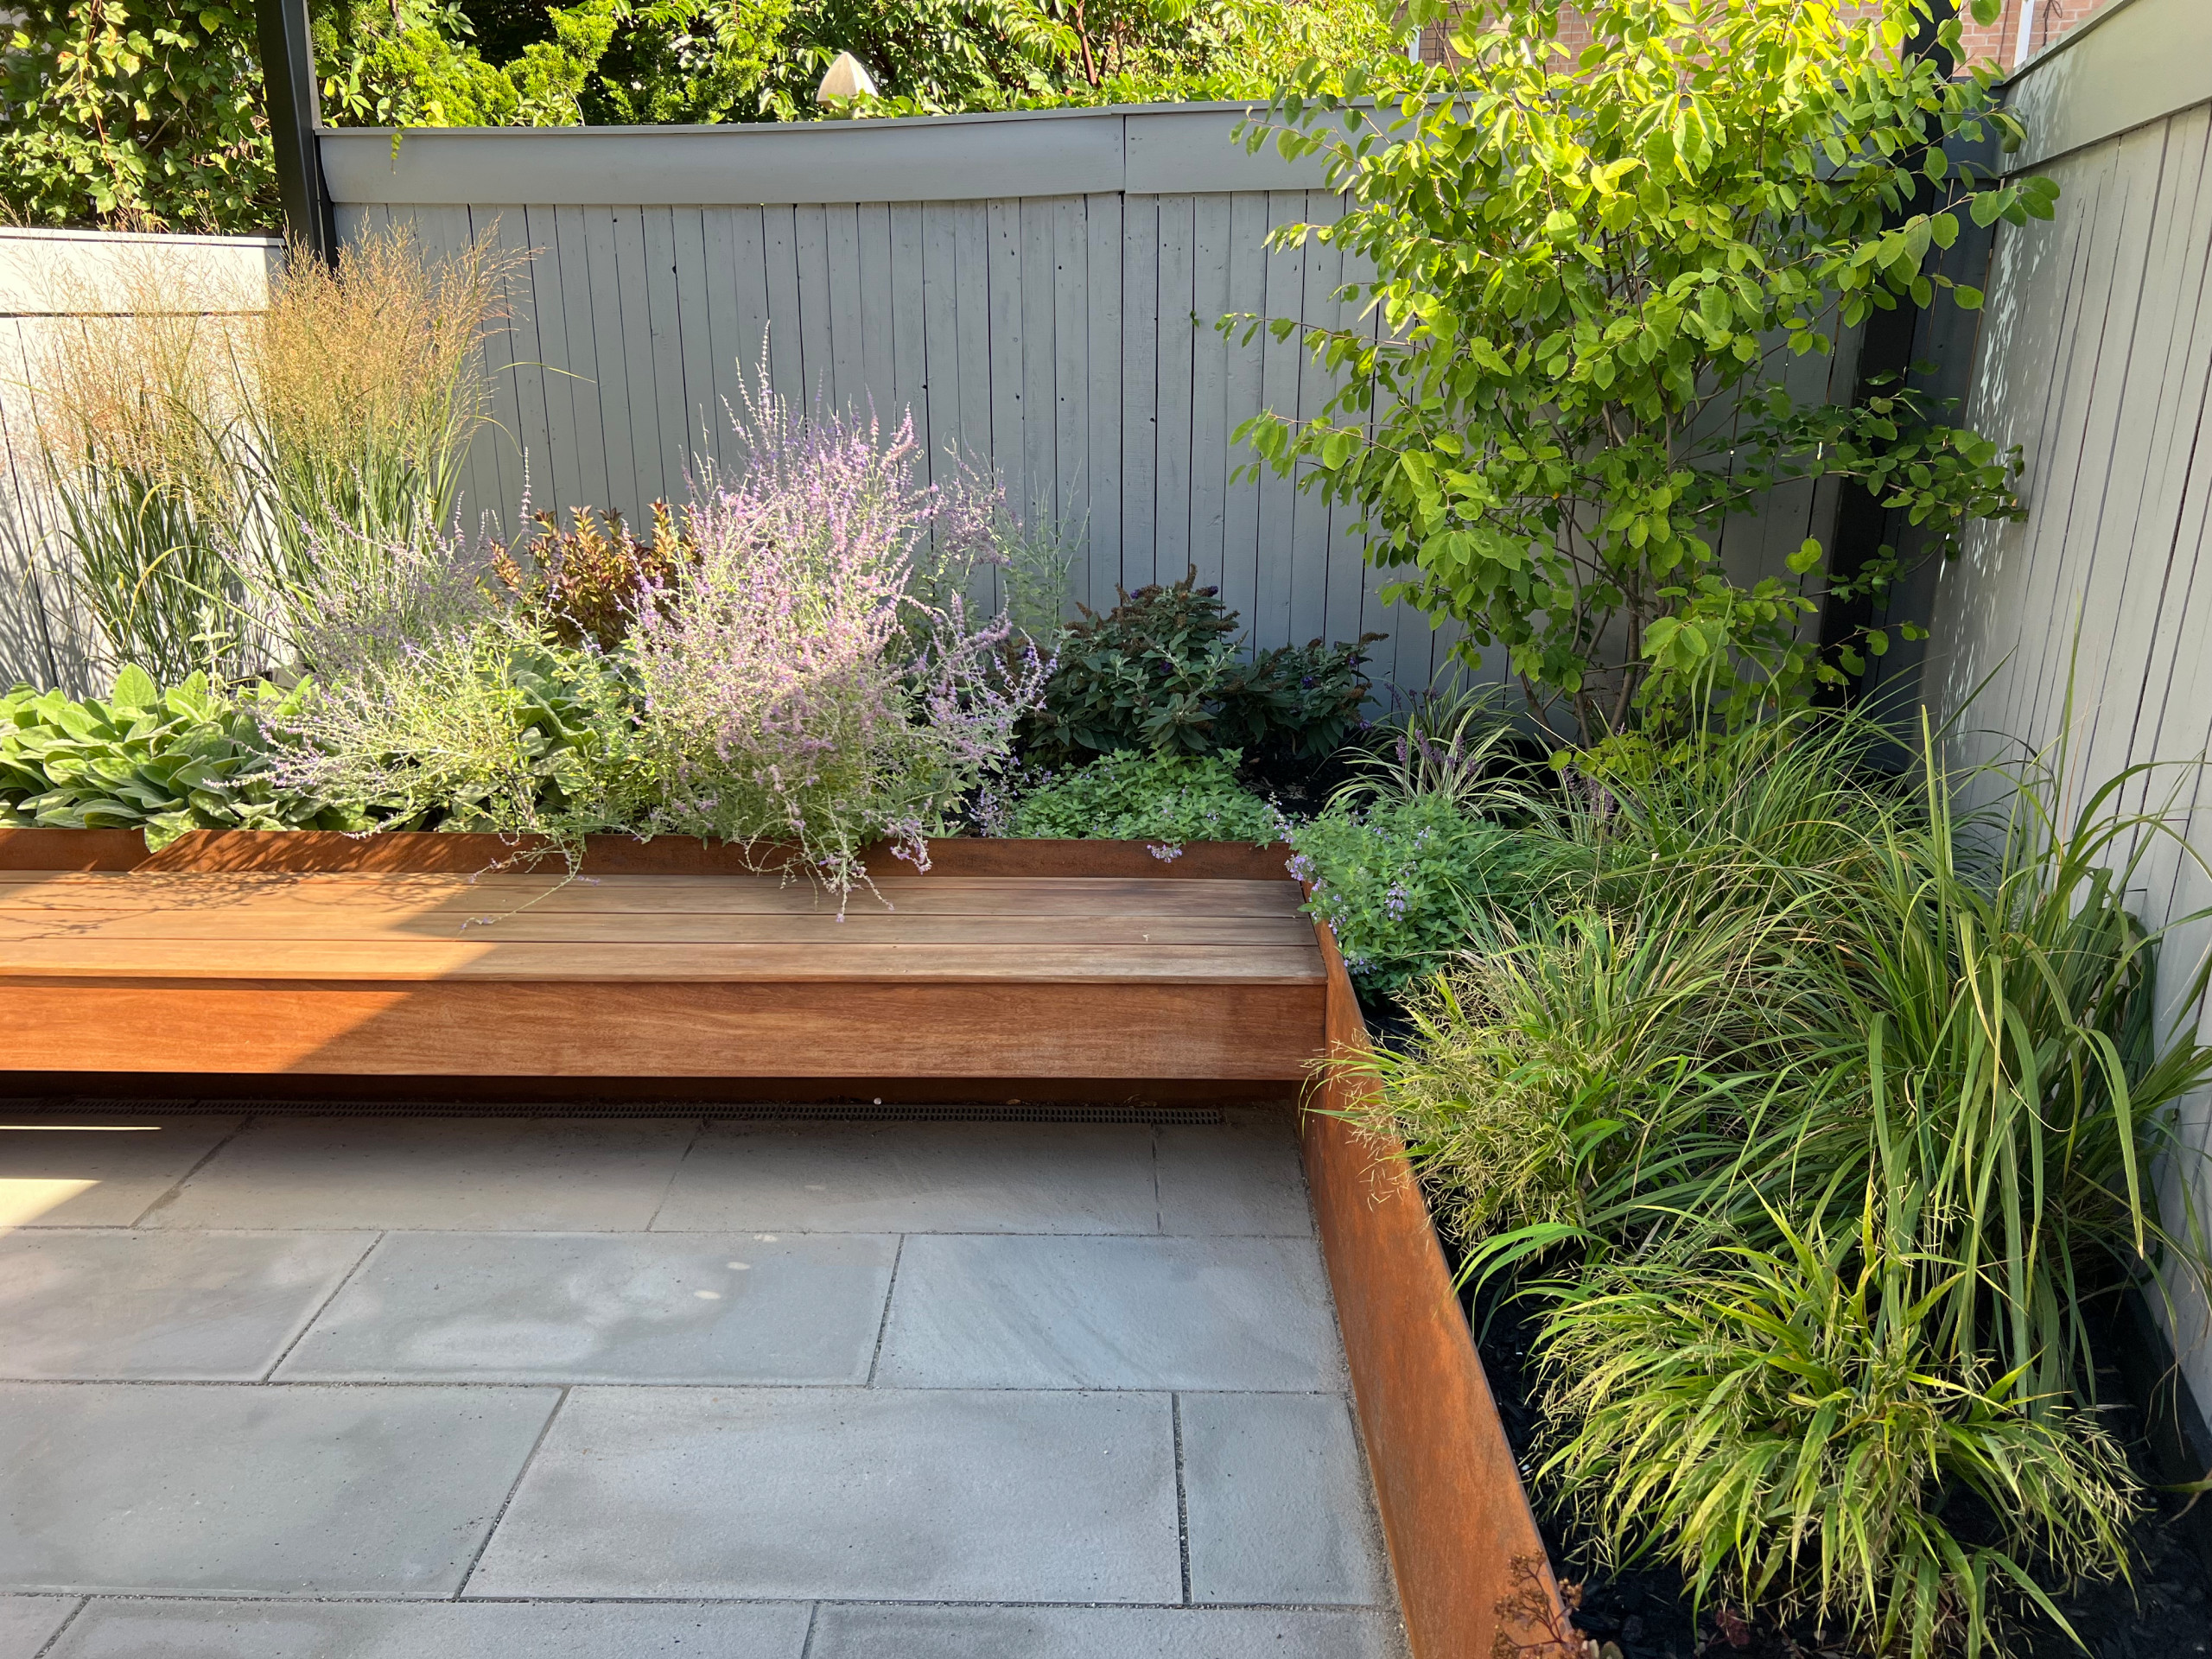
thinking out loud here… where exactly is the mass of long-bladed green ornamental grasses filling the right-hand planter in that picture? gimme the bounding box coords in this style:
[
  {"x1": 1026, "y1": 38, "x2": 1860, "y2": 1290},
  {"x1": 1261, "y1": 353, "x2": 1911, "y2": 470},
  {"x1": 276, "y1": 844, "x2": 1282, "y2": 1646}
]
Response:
[{"x1": 1376, "y1": 710, "x2": 2212, "y2": 1659}]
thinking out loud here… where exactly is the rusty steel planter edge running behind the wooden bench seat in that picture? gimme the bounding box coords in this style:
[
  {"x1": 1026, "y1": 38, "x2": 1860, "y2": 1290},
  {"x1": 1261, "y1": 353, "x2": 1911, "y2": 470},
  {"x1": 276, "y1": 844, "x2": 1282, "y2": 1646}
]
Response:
[{"x1": 0, "y1": 827, "x2": 1289, "y2": 880}]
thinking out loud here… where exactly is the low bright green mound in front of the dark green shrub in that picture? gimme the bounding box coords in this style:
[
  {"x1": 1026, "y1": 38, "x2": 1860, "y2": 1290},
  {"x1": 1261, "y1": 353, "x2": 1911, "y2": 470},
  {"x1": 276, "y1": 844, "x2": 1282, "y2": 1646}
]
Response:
[{"x1": 1004, "y1": 750, "x2": 1285, "y2": 842}]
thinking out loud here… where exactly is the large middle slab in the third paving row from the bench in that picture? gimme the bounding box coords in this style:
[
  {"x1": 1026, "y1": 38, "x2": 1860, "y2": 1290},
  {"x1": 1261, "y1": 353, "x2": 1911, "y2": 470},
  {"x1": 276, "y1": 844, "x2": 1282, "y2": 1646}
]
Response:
[{"x1": 469, "y1": 1389, "x2": 1181, "y2": 1601}]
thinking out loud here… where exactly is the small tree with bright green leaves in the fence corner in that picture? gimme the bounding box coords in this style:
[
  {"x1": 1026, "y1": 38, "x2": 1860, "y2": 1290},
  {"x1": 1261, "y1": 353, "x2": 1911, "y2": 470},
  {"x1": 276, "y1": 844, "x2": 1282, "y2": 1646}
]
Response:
[{"x1": 1230, "y1": 0, "x2": 2057, "y2": 741}]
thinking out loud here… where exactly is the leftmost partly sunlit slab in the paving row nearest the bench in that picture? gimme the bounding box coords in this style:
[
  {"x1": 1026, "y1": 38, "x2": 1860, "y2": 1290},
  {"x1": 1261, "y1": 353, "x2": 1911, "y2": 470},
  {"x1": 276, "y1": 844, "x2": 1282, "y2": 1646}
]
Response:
[{"x1": 0, "y1": 1119, "x2": 238, "y2": 1228}]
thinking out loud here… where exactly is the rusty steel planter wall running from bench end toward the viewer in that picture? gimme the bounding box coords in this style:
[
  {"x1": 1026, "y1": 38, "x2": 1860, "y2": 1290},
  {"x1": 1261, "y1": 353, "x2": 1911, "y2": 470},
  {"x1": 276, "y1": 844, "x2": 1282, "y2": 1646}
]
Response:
[{"x1": 1299, "y1": 920, "x2": 1588, "y2": 1659}]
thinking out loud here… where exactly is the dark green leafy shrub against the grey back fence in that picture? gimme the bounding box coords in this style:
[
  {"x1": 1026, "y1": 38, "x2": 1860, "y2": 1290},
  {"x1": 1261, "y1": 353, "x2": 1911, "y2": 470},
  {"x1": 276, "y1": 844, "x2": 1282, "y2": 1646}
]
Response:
[{"x1": 1024, "y1": 566, "x2": 1382, "y2": 763}]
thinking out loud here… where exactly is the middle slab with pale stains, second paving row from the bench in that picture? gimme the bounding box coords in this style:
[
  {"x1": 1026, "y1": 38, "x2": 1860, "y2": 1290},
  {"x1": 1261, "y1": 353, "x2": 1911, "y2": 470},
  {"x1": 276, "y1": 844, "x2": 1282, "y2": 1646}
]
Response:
[{"x1": 279, "y1": 1232, "x2": 898, "y2": 1382}]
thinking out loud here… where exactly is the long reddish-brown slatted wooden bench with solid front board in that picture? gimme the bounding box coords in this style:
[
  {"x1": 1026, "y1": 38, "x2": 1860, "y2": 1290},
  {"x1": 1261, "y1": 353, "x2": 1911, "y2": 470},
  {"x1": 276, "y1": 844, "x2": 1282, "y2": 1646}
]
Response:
[{"x1": 0, "y1": 838, "x2": 1325, "y2": 1082}]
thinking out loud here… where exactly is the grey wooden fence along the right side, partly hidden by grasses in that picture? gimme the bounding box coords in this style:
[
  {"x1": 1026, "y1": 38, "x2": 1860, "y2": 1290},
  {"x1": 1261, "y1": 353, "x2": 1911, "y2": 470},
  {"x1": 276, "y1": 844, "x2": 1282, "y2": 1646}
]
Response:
[{"x1": 1923, "y1": 0, "x2": 2212, "y2": 1405}]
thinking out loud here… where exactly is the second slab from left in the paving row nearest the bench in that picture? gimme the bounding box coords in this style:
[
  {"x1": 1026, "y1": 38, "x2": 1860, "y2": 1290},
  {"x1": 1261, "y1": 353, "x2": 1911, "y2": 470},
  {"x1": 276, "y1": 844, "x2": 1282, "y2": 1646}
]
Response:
[{"x1": 143, "y1": 1117, "x2": 699, "y2": 1232}]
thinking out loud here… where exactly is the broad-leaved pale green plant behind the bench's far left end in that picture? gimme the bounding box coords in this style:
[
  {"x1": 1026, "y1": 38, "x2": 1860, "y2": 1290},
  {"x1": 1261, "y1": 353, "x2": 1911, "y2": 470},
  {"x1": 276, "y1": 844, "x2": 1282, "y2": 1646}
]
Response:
[{"x1": 0, "y1": 668, "x2": 365, "y2": 852}]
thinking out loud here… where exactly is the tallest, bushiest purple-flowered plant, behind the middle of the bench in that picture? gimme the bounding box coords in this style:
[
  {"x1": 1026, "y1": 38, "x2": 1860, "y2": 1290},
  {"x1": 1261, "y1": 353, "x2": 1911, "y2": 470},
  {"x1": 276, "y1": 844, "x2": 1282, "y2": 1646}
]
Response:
[{"x1": 621, "y1": 390, "x2": 1048, "y2": 889}]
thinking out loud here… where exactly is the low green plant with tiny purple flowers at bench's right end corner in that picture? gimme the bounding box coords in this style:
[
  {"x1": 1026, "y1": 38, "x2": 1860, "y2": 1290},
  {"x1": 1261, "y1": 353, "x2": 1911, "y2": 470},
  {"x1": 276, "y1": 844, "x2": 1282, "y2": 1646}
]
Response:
[{"x1": 1289, "y1": 794, "x2": 1553, "y2": 995}]
